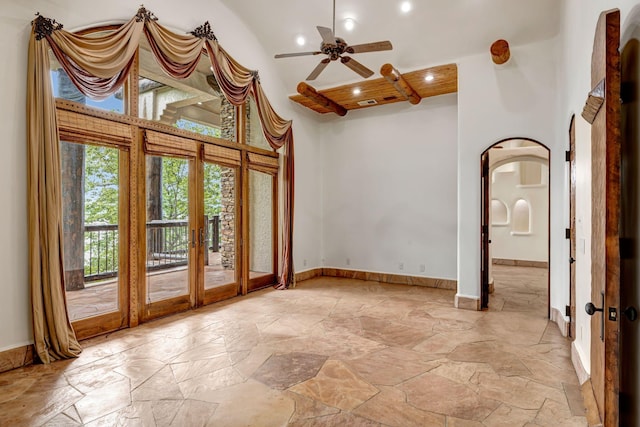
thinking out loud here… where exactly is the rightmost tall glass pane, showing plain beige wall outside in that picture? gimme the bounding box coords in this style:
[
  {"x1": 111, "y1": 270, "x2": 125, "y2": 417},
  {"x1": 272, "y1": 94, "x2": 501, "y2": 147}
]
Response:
[{"x1": 249, "y1": 170, "x2": 274, "y2": 279}]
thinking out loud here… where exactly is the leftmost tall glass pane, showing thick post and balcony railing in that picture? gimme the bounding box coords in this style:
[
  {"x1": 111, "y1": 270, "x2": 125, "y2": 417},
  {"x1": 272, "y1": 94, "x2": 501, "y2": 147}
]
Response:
[{"x1": 60, "y1": 141, "x2": 120, "y2": 321}]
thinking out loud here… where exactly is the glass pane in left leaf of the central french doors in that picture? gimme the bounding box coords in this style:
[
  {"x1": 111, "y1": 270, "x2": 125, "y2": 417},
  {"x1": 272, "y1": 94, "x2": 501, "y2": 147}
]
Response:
[{"x1": 146, "y1": 156, "x2": 191, "y2": 303}]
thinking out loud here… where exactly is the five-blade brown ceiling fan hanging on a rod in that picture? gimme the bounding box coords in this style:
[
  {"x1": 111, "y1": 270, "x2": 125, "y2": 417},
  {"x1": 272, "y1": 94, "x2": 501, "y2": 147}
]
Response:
[{"x1": 275, "y1": 0, "x2": 393, "y2": 80}]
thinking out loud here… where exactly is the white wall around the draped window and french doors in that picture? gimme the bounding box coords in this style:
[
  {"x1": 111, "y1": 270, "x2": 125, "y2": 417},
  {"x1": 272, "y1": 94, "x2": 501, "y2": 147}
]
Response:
[{"x1": 0, "y1": 0, "x2": 321, "y2": 351}]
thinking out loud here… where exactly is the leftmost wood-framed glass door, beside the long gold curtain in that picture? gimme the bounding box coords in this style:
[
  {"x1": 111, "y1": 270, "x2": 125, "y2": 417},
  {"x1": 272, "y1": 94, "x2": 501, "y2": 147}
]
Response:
[{"x1": 60, "y1": 139, "x2": 129, "y2": 337}]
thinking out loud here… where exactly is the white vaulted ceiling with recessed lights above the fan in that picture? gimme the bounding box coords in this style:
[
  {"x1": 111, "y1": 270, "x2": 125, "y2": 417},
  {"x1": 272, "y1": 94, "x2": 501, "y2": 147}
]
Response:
[{"x1": 221, "y1": 0, "x2": 562, "y2": 93}]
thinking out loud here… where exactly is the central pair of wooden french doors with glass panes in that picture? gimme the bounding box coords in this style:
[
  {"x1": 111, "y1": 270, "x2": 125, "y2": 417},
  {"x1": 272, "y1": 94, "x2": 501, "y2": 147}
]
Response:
[{"x1": 143, "y1": 130, "x2": 241, "y2": 320}]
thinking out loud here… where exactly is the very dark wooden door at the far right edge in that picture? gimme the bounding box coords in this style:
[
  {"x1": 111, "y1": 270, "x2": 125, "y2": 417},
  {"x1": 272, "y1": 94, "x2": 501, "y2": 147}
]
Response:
[{"x1": 620, "y1": 23, "x2": 640, "y2": 426}]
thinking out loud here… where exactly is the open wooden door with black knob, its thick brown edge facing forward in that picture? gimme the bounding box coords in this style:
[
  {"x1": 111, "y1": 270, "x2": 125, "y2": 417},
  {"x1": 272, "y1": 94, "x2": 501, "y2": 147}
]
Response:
[{"x1": 583, "y1": 10, "x2": 620, "y2": 427}]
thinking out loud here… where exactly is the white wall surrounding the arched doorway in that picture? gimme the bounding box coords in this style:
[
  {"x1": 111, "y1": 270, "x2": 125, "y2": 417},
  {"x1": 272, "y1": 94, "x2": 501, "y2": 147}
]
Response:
[{"x1": 457, "y1": 39, "x2": 568, "y2": 307}]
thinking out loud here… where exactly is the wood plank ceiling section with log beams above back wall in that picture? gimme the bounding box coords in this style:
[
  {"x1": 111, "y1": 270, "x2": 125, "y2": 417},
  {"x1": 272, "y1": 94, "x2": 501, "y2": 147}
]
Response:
[{"x1": 289, "y1": 64, "x2": 458, "y2": 116}]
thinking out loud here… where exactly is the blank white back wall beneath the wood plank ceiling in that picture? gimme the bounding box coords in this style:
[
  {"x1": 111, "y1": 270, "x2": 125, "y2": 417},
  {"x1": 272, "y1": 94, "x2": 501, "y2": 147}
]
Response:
[{"x1": 319, "y1": 95, "x2": 457, "y2": 279}]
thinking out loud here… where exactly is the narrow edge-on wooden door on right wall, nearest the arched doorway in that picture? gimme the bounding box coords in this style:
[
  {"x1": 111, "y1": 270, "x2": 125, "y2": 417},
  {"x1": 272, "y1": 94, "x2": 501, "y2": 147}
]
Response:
[{"x1": 569, "y1": 116, "x2": 576, "y2": 339}]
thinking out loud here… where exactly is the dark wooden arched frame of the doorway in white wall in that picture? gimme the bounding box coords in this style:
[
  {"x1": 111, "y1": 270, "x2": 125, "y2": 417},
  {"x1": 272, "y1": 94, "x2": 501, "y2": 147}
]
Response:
[{"x1": 480, "y1": 137, "x2": 551, "y2": 312}]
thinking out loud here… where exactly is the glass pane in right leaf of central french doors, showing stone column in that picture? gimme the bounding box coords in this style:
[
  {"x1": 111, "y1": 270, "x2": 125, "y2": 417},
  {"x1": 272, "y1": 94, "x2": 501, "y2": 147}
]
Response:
[{"x1": 204, "y1": 163, "x2": 236, "y2": 289}]
